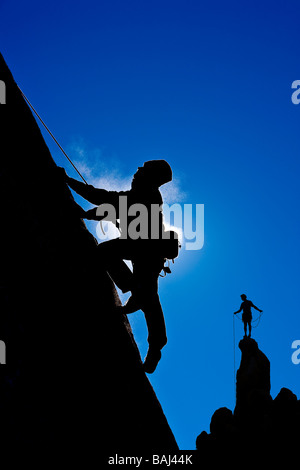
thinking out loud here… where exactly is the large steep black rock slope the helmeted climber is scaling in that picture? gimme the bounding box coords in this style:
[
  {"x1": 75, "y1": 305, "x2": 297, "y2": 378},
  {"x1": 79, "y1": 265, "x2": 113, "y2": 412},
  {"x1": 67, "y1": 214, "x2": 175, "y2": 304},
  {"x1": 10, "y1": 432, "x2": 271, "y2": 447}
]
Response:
[{"x1": 0, "y1": 56, "x2": 177, "y2": 458}]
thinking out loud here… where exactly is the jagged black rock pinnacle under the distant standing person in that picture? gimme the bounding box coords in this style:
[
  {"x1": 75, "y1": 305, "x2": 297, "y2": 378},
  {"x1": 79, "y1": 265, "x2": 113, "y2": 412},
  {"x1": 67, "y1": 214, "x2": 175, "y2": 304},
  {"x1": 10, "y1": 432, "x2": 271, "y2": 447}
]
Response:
[{"x1": 196, "y1": 338, "x2": 300, "y2": 464}]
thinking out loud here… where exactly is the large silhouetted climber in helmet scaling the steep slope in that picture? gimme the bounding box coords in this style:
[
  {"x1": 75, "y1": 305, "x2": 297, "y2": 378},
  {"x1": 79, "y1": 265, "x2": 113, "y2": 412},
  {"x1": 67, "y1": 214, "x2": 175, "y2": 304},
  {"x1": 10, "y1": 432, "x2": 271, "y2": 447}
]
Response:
[{"x1": 59, "y1": 160, "x2": 178, "y2": 373}]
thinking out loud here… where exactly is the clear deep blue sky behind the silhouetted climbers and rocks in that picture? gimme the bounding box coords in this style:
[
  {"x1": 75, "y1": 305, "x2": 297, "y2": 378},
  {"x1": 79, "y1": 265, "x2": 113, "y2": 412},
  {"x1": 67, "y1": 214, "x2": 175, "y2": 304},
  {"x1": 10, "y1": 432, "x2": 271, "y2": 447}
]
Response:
[{"x1": 0, "y1": 0, "x2": 300, "y2": 449}]
